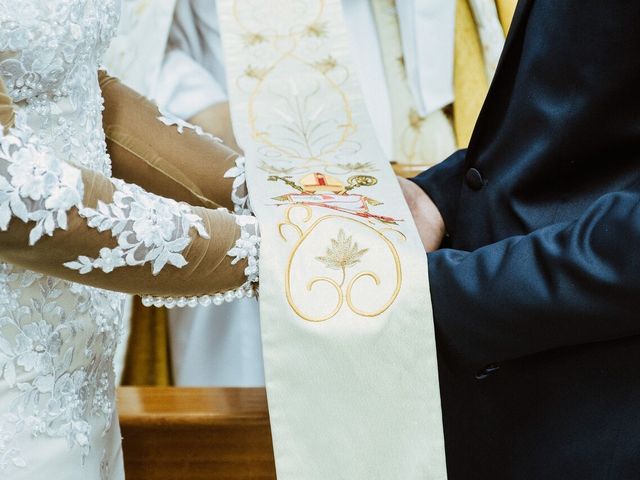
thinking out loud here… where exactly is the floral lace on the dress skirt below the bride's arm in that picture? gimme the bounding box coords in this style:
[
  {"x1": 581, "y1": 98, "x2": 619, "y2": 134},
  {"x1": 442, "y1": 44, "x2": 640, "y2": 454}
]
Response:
[{"x1": 0, "y1": 264, "x2": 125, "y2": 472}]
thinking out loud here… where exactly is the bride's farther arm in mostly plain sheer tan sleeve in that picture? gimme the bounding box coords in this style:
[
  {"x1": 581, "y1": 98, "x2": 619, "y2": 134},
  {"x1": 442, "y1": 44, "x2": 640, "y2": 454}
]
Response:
[{"x1": 100, "y1": 72, "x2": 246, "y2": 215}]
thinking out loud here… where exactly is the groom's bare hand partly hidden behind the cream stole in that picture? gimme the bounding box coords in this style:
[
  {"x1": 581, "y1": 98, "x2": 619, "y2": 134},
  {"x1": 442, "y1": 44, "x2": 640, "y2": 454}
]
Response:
[{"x1": 398, "y1": 177, "x2": 445, "y2": 252}]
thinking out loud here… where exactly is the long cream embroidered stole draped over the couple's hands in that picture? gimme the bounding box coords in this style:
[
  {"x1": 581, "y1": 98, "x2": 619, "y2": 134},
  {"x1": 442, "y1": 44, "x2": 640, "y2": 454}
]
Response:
[{"x1": 218, "y1": 0, "x2": 446, "y2": 480}]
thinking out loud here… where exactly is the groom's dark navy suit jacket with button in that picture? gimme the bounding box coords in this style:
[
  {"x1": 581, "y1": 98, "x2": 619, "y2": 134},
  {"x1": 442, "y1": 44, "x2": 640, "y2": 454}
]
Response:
[{"x1": 414, "y1": 0, "x2": 640, "y2": 480}]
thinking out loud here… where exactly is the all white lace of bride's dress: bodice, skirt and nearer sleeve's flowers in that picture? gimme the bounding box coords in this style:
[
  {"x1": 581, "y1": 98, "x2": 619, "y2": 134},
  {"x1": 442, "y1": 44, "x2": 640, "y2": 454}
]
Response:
[{"x1": 0, "y1": 0, "x2": 259, "y2": 480}]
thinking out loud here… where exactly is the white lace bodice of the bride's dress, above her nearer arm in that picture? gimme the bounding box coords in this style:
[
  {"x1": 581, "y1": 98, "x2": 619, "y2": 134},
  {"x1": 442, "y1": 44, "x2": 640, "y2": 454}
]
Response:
[{"x1": 0, "y1": 0, "x2": 119, "y2": 175}]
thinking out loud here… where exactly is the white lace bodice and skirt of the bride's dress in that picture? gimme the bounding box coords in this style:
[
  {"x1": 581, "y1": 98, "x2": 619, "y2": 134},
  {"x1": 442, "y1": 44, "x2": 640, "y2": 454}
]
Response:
[{"x1": 0, "y1": 0, "x2": 154, "y2": 480}]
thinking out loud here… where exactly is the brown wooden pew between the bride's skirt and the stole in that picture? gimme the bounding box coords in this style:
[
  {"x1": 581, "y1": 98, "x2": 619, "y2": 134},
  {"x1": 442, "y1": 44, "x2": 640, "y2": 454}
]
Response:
[{"x1": 118, "y1": 387, "x2": 275, "y2": 480}]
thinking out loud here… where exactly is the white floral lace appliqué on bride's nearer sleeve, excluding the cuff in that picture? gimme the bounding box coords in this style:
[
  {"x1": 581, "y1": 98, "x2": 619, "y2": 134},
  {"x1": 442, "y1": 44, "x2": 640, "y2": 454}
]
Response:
[{"x1": 0, "y1": 110, "x2": 209, "y2": 275}]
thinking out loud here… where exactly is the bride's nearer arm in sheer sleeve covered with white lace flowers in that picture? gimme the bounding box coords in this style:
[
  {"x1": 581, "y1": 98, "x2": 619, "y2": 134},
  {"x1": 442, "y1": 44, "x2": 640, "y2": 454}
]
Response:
[{"x1": 0, "y1": 80, "x2": 258, "y2": 302}]
